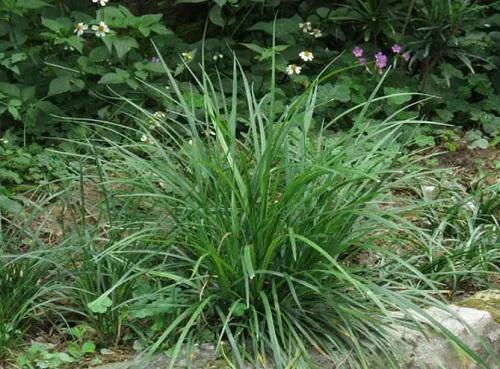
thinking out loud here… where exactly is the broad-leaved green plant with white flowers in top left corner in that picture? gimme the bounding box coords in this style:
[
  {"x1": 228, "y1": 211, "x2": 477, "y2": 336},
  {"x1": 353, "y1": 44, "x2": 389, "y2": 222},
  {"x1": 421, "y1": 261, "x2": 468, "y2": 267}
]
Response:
[{"x1": 0, "y1": 0, "x2": 169, "y2": 142}]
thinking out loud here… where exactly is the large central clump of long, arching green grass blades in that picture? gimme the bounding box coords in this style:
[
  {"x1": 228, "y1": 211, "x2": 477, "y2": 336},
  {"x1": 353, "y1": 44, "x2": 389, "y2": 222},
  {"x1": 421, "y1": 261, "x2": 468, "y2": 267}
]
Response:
[{"x1": 74, "y1": 52, "x2": 492, "y2": 369}]
